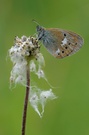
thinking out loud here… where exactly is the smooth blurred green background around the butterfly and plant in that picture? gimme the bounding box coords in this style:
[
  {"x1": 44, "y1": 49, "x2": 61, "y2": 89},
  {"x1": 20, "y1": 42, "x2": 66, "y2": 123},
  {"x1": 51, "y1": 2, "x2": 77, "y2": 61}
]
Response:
[{"x1": 0, "y1": 0, "x2": 89, "y2": 135}]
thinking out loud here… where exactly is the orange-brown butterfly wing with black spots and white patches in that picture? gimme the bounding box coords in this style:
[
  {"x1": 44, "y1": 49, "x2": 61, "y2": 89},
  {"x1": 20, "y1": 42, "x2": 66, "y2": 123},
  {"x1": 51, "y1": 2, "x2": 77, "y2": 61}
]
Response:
[{"x1": 42, "y1": 28, "x2": 83, "y2": 58}]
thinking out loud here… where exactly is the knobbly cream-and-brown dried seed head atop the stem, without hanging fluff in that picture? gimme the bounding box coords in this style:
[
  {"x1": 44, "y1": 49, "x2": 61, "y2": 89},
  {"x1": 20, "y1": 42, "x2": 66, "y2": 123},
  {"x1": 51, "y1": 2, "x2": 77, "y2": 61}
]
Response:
[{"x1": 9, "y1": 36, "x2": 40, "y2": 58}]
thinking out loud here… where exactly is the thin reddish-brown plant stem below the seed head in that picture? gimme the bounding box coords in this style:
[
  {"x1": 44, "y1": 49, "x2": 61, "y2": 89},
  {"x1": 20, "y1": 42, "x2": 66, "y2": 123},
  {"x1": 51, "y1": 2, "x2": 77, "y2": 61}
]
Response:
[{"x1": 22, "y1": 62, "x2": 30, "y2": 135}]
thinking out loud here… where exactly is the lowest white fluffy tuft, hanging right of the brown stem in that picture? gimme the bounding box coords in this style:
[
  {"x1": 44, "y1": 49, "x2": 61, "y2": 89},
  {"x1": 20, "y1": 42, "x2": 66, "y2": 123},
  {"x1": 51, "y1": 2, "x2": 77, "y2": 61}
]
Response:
[{"x1": 29, "y1": 87, "x2": 57, "y2": 117}]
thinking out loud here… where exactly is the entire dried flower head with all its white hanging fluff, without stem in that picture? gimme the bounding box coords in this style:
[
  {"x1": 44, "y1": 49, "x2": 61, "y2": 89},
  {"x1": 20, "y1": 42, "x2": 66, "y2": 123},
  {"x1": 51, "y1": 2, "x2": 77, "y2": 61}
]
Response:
[{"x1": 9, "y1": 36, "x2": 56, "y2": 117}]
